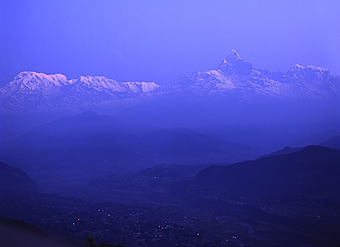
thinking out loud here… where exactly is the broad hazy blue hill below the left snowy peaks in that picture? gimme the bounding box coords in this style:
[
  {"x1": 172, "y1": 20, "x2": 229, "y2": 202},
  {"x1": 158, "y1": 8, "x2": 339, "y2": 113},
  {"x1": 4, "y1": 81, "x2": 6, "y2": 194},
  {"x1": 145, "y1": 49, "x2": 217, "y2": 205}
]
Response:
[{"x1": 0, "y1": 112, "x2": 257, "y2": 173}]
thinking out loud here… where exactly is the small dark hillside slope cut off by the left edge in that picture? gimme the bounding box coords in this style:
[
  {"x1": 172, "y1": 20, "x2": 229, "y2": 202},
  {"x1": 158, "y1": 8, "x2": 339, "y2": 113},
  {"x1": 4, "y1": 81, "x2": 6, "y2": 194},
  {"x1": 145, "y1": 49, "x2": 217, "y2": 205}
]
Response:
[{"x1": 0, "y1": 162, "x2": 38, "y2": 192}]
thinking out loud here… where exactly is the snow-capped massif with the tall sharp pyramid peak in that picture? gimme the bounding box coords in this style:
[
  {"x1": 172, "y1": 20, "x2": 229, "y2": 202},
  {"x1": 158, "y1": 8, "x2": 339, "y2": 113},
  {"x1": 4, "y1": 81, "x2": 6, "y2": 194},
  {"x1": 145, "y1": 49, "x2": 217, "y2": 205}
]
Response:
[{"x1": 168, "y1": 50, "x2": 340, "y2": 98}]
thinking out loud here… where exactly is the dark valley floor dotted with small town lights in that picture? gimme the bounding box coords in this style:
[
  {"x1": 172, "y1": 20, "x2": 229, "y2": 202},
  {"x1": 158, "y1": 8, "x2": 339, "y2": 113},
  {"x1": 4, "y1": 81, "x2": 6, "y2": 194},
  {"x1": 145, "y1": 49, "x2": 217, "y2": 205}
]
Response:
[{"x1": 0, "y1": 172, "x2": 340, "y2": 247}]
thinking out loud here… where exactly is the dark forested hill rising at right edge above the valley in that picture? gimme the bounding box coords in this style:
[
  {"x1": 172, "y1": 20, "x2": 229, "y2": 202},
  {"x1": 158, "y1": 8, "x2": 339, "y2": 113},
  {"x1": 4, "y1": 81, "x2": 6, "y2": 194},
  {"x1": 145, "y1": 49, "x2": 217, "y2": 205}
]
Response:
[{"x1": 196, "y1": 146, "x2": 340, "y2": 196}]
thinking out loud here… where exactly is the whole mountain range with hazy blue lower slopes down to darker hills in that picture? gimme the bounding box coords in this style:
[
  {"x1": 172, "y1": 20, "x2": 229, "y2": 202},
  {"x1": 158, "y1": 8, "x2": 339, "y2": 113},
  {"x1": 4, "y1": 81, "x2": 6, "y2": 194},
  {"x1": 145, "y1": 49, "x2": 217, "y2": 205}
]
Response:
[{"x1": 0, "y1": 51, "x2": 340, "y2": 149}]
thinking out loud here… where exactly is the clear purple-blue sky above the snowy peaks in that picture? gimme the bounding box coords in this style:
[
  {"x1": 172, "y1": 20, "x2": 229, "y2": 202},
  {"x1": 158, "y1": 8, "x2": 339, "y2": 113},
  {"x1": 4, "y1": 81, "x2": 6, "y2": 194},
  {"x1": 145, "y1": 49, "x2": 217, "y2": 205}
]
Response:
[{"x1": 0, "y1": 0, "x2": 340, "y2": 85}]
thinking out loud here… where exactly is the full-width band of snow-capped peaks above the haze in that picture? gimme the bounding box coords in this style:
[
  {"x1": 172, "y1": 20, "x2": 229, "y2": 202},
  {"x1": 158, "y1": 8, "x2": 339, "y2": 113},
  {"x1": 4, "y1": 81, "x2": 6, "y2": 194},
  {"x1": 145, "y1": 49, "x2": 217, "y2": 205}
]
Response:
[{"x1": 0, "y1": 50, "x2": 340, "y2": 112}]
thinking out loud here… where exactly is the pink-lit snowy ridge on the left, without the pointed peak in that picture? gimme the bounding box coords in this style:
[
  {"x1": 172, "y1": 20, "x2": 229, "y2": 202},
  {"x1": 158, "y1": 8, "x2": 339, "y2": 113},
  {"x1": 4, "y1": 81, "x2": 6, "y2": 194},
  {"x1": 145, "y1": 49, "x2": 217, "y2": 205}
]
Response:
[{"x1": 0, "y1": 72, "x2": 159, "y2": 111}]
